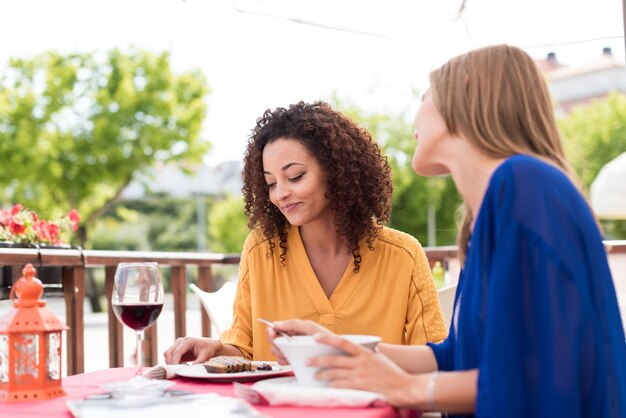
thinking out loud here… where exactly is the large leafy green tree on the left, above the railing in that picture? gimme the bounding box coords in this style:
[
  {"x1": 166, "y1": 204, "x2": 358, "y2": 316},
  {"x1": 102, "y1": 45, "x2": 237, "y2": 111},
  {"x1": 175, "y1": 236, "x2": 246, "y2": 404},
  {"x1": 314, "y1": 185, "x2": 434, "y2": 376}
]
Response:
[{"x1": 0, "y1": 50, "x2": 209, "y2": 245}]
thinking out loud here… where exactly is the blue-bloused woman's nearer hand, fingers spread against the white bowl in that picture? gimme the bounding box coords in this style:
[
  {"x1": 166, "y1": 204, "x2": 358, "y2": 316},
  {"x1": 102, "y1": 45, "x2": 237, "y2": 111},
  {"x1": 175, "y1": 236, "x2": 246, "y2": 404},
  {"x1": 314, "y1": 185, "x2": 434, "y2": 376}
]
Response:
[{"x1": 309, "y1": 333, "x2": 425, "y2": 408}]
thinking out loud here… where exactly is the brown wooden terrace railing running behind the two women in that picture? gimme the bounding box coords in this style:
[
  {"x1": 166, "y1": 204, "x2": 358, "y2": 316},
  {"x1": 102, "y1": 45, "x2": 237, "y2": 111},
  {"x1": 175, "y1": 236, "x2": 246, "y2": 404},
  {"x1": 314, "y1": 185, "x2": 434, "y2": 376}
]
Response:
[{"x1": 0, "y1": 241, "x2": 626, "y2": 375}]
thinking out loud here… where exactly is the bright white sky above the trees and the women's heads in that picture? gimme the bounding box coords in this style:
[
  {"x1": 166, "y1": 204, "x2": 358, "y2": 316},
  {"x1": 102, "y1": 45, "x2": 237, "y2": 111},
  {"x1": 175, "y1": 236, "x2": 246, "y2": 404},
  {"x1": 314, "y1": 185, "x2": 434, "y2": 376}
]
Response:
[{"x1": 0, "y1": 0, "x2": 624, "y2": 162}]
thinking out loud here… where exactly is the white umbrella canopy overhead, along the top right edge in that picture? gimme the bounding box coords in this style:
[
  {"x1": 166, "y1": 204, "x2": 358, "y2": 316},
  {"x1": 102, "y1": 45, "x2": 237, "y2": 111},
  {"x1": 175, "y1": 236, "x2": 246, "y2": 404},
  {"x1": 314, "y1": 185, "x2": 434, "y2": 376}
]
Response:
[{"x1": 230, "y1": 0, "x2": 626, "y2": 49}]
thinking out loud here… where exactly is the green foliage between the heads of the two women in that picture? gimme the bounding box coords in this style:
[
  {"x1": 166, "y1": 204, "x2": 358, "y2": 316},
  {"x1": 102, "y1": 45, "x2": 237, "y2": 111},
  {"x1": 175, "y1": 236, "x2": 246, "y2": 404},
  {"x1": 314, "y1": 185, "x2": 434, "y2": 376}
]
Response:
[{"x1": 334, "y1": 97, "x2": 461, "y2": 245}]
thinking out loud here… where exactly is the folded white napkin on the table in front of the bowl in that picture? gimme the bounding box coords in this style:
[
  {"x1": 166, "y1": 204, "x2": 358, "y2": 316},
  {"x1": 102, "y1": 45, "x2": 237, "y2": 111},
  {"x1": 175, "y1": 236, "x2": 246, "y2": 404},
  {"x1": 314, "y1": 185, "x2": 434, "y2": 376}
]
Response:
[{"x1": 252, "y1": 377, "x2": 386, "y2": 407}]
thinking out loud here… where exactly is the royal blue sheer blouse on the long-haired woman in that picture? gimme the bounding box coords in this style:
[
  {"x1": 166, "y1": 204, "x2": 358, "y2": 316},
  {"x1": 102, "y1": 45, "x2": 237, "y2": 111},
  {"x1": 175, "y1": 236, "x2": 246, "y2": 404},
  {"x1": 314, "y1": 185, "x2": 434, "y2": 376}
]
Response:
[{"x1": 429, "y1": 155, "x2": 626, "y2": 418}]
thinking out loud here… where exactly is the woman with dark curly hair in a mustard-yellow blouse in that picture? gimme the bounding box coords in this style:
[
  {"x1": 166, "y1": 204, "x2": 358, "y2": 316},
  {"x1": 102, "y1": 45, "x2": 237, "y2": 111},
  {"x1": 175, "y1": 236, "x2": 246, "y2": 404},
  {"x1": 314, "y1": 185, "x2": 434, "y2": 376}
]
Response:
[{"x1": 165, "y1": 102, "x2": 447, "y2": 363}]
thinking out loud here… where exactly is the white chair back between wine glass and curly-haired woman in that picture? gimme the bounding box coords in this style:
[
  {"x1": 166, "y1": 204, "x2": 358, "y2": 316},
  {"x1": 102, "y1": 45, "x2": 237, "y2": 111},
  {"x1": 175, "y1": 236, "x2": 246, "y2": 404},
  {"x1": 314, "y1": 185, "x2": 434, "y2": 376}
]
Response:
[{"x1": 189, "y1": 281, "x2": 237, "y2": 338}]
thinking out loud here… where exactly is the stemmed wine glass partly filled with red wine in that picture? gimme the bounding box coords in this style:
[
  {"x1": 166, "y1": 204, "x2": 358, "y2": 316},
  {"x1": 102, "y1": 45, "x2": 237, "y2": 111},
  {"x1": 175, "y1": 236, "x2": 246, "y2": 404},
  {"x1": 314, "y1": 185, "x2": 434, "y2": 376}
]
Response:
[{"x1": 111, "y1": 263, "x2": 163, "y2": 386}]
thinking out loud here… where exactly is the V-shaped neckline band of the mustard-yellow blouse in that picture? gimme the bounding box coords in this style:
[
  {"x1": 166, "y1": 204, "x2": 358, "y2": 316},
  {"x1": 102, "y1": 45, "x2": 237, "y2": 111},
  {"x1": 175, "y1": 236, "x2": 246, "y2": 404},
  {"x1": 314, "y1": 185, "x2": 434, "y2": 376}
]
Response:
[{"x1": 288, "y1": 226, "x2": 363, "y2": 314}]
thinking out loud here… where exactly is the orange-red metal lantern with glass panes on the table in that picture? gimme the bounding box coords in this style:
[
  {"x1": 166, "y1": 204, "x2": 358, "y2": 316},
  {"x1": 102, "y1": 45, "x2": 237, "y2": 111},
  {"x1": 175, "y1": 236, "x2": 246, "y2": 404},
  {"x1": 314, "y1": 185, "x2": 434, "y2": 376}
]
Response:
[{"x1": 0, "y1": 264, "x2": 68, "y2": 402}]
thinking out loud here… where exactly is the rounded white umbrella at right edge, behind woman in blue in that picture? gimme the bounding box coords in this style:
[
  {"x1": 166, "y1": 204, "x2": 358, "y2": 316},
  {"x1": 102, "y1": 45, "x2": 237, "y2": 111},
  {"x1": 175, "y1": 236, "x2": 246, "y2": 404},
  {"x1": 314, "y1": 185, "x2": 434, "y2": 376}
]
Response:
[{"x1": 591, "y1": 152, "x2": 626, "y2": 219}]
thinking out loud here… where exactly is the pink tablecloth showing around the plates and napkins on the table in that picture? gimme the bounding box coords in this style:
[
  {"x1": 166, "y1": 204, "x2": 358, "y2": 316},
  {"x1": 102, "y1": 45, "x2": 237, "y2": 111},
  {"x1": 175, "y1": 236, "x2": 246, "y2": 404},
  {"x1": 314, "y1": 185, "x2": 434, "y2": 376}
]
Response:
[{"x1": 0, "y1": 368, "x2": 411, "y2": 418}]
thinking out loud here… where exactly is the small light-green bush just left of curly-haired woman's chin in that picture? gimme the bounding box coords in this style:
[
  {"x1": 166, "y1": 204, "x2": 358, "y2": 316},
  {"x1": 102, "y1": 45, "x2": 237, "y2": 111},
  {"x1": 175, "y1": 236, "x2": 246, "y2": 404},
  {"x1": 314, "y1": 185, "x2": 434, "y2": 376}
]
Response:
[{"x1": 209, "y1": 195, "x2": 250, "y2": 253}]
